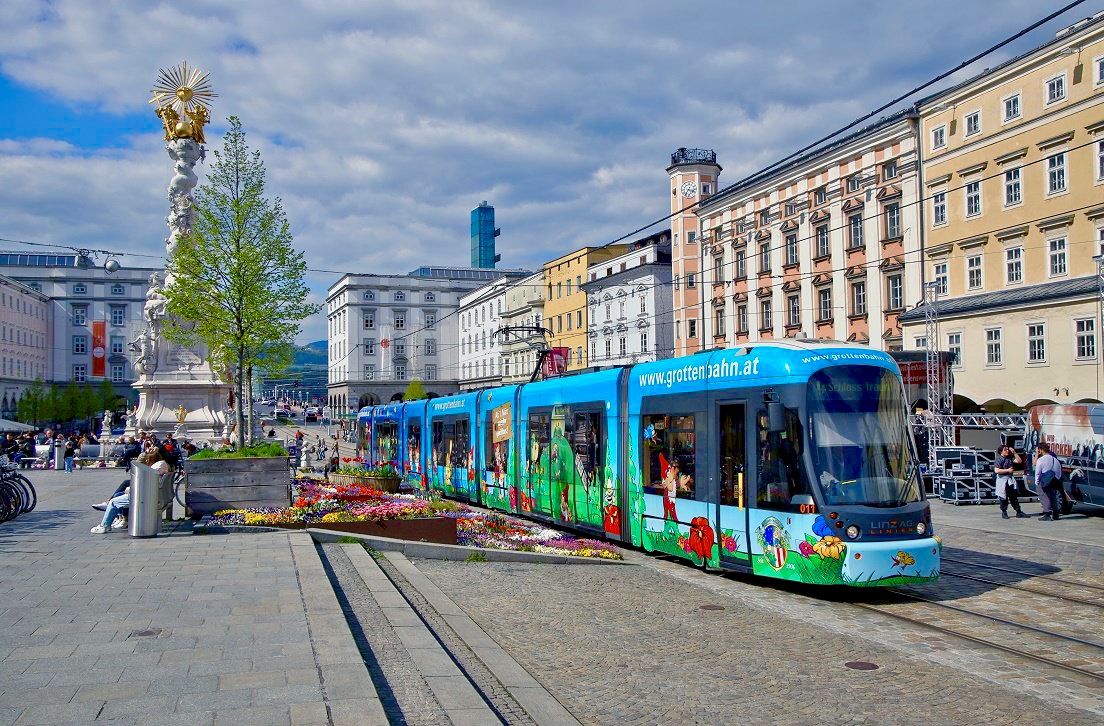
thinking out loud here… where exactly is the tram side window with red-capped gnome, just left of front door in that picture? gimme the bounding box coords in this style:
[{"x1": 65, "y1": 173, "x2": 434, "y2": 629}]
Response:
[{"x1": 640, "y1": 414, "x2": 697, "y2": 499}]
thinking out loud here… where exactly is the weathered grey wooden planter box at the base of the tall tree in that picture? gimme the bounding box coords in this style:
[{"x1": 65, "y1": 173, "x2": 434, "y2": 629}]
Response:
[{"x1": 184, "y1": 457, "x2": 291, "y2": 515}]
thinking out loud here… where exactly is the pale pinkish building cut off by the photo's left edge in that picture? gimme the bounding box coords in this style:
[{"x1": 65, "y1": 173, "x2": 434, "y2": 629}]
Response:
[{"x1": 0, "y1": 276, "x2": 51, "y2": 418}]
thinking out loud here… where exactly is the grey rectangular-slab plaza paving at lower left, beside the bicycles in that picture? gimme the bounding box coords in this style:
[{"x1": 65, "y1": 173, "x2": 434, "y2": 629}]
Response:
[{"x1": 0, "y1": 469, "x2": 370, "y2": 726}]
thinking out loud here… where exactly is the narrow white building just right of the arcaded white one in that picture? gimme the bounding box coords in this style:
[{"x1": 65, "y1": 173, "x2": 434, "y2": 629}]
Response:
[{"x1": 459, "y1": 275, "x2": 527, "y2": 391}]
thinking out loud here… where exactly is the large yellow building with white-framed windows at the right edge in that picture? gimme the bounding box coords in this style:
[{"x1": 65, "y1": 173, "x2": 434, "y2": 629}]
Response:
[{"x1": 901, "y1": 15, "x2": 1104, "y2": 413}]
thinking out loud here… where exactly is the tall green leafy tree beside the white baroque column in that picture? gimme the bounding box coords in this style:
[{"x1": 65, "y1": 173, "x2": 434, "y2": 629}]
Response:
[{"x1": 164, "y1": 116, "x2": 321, "y2": 448}]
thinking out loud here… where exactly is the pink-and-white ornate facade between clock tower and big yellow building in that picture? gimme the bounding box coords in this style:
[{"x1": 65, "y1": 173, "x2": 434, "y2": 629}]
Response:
[{"x1": 676, "y1": 109, "x2": 921, "y2": 350}]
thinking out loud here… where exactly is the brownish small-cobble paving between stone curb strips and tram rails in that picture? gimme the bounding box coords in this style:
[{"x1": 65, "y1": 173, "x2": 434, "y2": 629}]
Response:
[{"x1": 416, "y1": 559, "x2": 1098, "y2": 724}]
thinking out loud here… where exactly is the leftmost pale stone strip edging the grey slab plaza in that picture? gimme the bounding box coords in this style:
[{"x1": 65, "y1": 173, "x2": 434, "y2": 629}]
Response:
[{"x1": 288, "y1": 532, "x2": 389, "y2": 726}]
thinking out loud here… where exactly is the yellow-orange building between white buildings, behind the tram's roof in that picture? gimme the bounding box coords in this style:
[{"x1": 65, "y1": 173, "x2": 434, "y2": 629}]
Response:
[{"x1": 544, "y1": 245, "x2": 628, "y2": 371}]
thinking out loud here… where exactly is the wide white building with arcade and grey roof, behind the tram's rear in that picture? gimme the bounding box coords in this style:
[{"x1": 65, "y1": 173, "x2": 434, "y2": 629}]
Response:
[{"x1": 326, "y1": 267, "x2": 527, "y2": 413}]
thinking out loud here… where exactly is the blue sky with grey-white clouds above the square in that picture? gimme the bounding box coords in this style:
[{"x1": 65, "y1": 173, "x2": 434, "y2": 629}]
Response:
[{"x1": 0, "y1": 0, "x2": 1090, "y2": 342}]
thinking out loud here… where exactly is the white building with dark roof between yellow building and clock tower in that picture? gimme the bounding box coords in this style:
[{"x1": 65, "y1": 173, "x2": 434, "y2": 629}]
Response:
[{"x1": 583, "y1": 229, "x2": 675, "y2": 367}]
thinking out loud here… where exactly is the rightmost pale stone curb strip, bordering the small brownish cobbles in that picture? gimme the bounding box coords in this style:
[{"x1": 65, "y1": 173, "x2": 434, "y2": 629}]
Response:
[{"x1": 381, "y1": 547, "x2": 582, "y2": 726}]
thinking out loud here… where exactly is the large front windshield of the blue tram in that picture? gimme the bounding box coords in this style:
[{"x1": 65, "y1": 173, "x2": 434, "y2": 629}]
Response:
[{"x1": 809, "y1": 366, "x2": 920, "y2": 506}]
